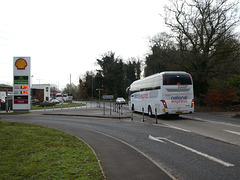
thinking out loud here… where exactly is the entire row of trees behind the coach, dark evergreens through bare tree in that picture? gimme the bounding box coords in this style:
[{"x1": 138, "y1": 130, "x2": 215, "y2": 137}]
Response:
[{"x1": 62, "y1": 0, "x2": 240, "y2": 108}]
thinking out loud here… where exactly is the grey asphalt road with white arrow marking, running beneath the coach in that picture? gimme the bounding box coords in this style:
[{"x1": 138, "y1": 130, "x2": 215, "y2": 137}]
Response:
[{"x1": 2, "y1": 104, "x2": 240, "y2": 180}]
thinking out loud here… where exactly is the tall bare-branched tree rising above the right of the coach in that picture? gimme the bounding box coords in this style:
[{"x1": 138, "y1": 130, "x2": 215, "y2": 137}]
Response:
[{"x1": 163, "y1": 0, "x2": 240, "y2": 95}]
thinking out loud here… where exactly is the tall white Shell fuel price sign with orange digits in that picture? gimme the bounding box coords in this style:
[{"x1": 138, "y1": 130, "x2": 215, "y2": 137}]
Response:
[{"x1": 13, "y1": 57, "x2": 31, "y2": 111}]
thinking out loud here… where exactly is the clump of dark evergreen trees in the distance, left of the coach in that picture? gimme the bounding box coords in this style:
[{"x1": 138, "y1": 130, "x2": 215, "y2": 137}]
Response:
[{"x1": 78, "y1": 51, "x2": 141, "y2": 99}]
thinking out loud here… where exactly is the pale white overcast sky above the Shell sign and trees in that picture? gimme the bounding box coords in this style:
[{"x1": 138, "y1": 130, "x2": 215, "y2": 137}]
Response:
[{"x1": 0, "y1": 0, "x2": 168, "y2": 88}]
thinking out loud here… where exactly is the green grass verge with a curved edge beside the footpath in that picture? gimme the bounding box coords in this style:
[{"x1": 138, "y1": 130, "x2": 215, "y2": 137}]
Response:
[{"x1": 0, "y1": 121, "x2": 104, "y2": 180}]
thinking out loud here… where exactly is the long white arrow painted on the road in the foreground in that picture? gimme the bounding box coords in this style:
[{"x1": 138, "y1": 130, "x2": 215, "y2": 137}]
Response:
[{"x1": 149, "y1": 135, "x2": 234, "y2": 167}]
